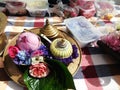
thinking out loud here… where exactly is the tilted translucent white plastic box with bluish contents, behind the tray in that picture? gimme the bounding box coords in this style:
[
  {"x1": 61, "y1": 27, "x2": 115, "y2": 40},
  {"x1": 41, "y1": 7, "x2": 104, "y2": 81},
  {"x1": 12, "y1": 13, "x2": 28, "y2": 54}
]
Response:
[{"x1": 64, "y1": 16, "x2": 103, "y2": 48}]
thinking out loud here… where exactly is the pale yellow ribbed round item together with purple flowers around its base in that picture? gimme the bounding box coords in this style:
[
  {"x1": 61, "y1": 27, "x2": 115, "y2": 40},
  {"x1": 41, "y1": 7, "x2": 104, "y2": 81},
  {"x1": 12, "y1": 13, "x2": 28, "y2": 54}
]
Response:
[{"x1": 50, "y1": 38, "x2": 79, "y2": 65}]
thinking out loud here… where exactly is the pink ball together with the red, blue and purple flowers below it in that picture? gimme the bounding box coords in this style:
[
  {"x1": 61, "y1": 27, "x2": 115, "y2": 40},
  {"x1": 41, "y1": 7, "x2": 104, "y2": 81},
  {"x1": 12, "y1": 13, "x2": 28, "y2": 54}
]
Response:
[{"x1": 8, "y1": 32, "x2": 48, "y2": 66}]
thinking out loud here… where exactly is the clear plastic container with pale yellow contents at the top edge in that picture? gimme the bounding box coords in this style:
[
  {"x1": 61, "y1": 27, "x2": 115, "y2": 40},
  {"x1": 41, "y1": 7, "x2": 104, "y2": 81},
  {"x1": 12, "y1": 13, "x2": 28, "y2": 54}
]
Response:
[{"x1": 24, "y1": 0, "x2": 49, "y2": 17}]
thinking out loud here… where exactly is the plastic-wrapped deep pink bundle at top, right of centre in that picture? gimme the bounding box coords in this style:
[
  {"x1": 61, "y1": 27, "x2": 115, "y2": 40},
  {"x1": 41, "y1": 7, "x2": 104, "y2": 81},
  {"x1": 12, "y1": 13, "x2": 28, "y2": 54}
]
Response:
[{"x1": 70, "y1": 0, "x2": 96, "y2": 18}]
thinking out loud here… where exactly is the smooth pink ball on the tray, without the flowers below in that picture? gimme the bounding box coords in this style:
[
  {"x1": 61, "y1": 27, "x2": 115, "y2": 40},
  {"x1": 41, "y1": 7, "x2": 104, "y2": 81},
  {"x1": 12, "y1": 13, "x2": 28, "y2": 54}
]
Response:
[{"x1": 16, "y1": 32, "x2": 41, "y2": 51}]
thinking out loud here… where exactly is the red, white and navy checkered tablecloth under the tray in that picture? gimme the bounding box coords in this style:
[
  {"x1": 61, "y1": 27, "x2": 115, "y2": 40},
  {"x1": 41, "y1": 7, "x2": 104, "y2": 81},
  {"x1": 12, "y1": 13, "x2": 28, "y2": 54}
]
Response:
[{"x1": 0, "y1": 16, "x2": 120, "y2": 90}]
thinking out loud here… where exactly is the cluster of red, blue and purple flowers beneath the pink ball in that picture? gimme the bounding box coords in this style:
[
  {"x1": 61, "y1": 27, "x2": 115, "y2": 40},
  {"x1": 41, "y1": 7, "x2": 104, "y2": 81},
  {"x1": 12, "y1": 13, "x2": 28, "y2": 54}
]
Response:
[{"x1": 8, "y1": 45, "x2": 48, "y2": 65}]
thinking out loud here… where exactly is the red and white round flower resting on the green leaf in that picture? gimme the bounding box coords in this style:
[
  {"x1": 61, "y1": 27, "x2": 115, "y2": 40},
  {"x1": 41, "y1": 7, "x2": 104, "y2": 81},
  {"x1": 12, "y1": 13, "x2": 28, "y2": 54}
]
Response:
[{"x1": 29, "y1": 62, "x2": 50, "y2": 78}]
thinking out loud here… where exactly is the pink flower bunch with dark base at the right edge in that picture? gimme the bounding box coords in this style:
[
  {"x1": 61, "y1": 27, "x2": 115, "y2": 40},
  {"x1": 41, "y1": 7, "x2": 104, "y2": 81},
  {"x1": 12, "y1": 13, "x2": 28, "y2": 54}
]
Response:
[{"x1": 97, "y1": 31, "x2": 120, "y2": 60}]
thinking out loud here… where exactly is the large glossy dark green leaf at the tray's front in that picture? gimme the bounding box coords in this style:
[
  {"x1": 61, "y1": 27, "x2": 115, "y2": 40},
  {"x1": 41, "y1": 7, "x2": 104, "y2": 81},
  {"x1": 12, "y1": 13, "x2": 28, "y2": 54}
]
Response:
[{"x1": 24, "y1": 59, "x2": 75, "y2": 90}]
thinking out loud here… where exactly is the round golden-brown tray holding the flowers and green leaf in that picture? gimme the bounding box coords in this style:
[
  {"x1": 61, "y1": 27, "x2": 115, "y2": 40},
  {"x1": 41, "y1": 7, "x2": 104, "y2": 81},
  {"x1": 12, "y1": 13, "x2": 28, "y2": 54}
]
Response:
[{"x1": 3, "y1": 28, "x2": 81, "y2": 87}]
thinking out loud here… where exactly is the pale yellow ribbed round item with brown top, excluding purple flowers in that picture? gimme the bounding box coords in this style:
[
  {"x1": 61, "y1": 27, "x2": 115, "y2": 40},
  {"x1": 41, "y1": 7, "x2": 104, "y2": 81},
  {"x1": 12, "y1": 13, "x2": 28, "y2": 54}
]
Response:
[{"x1": 50, "y1": 38, "x2": 73, "y2": 59}]
